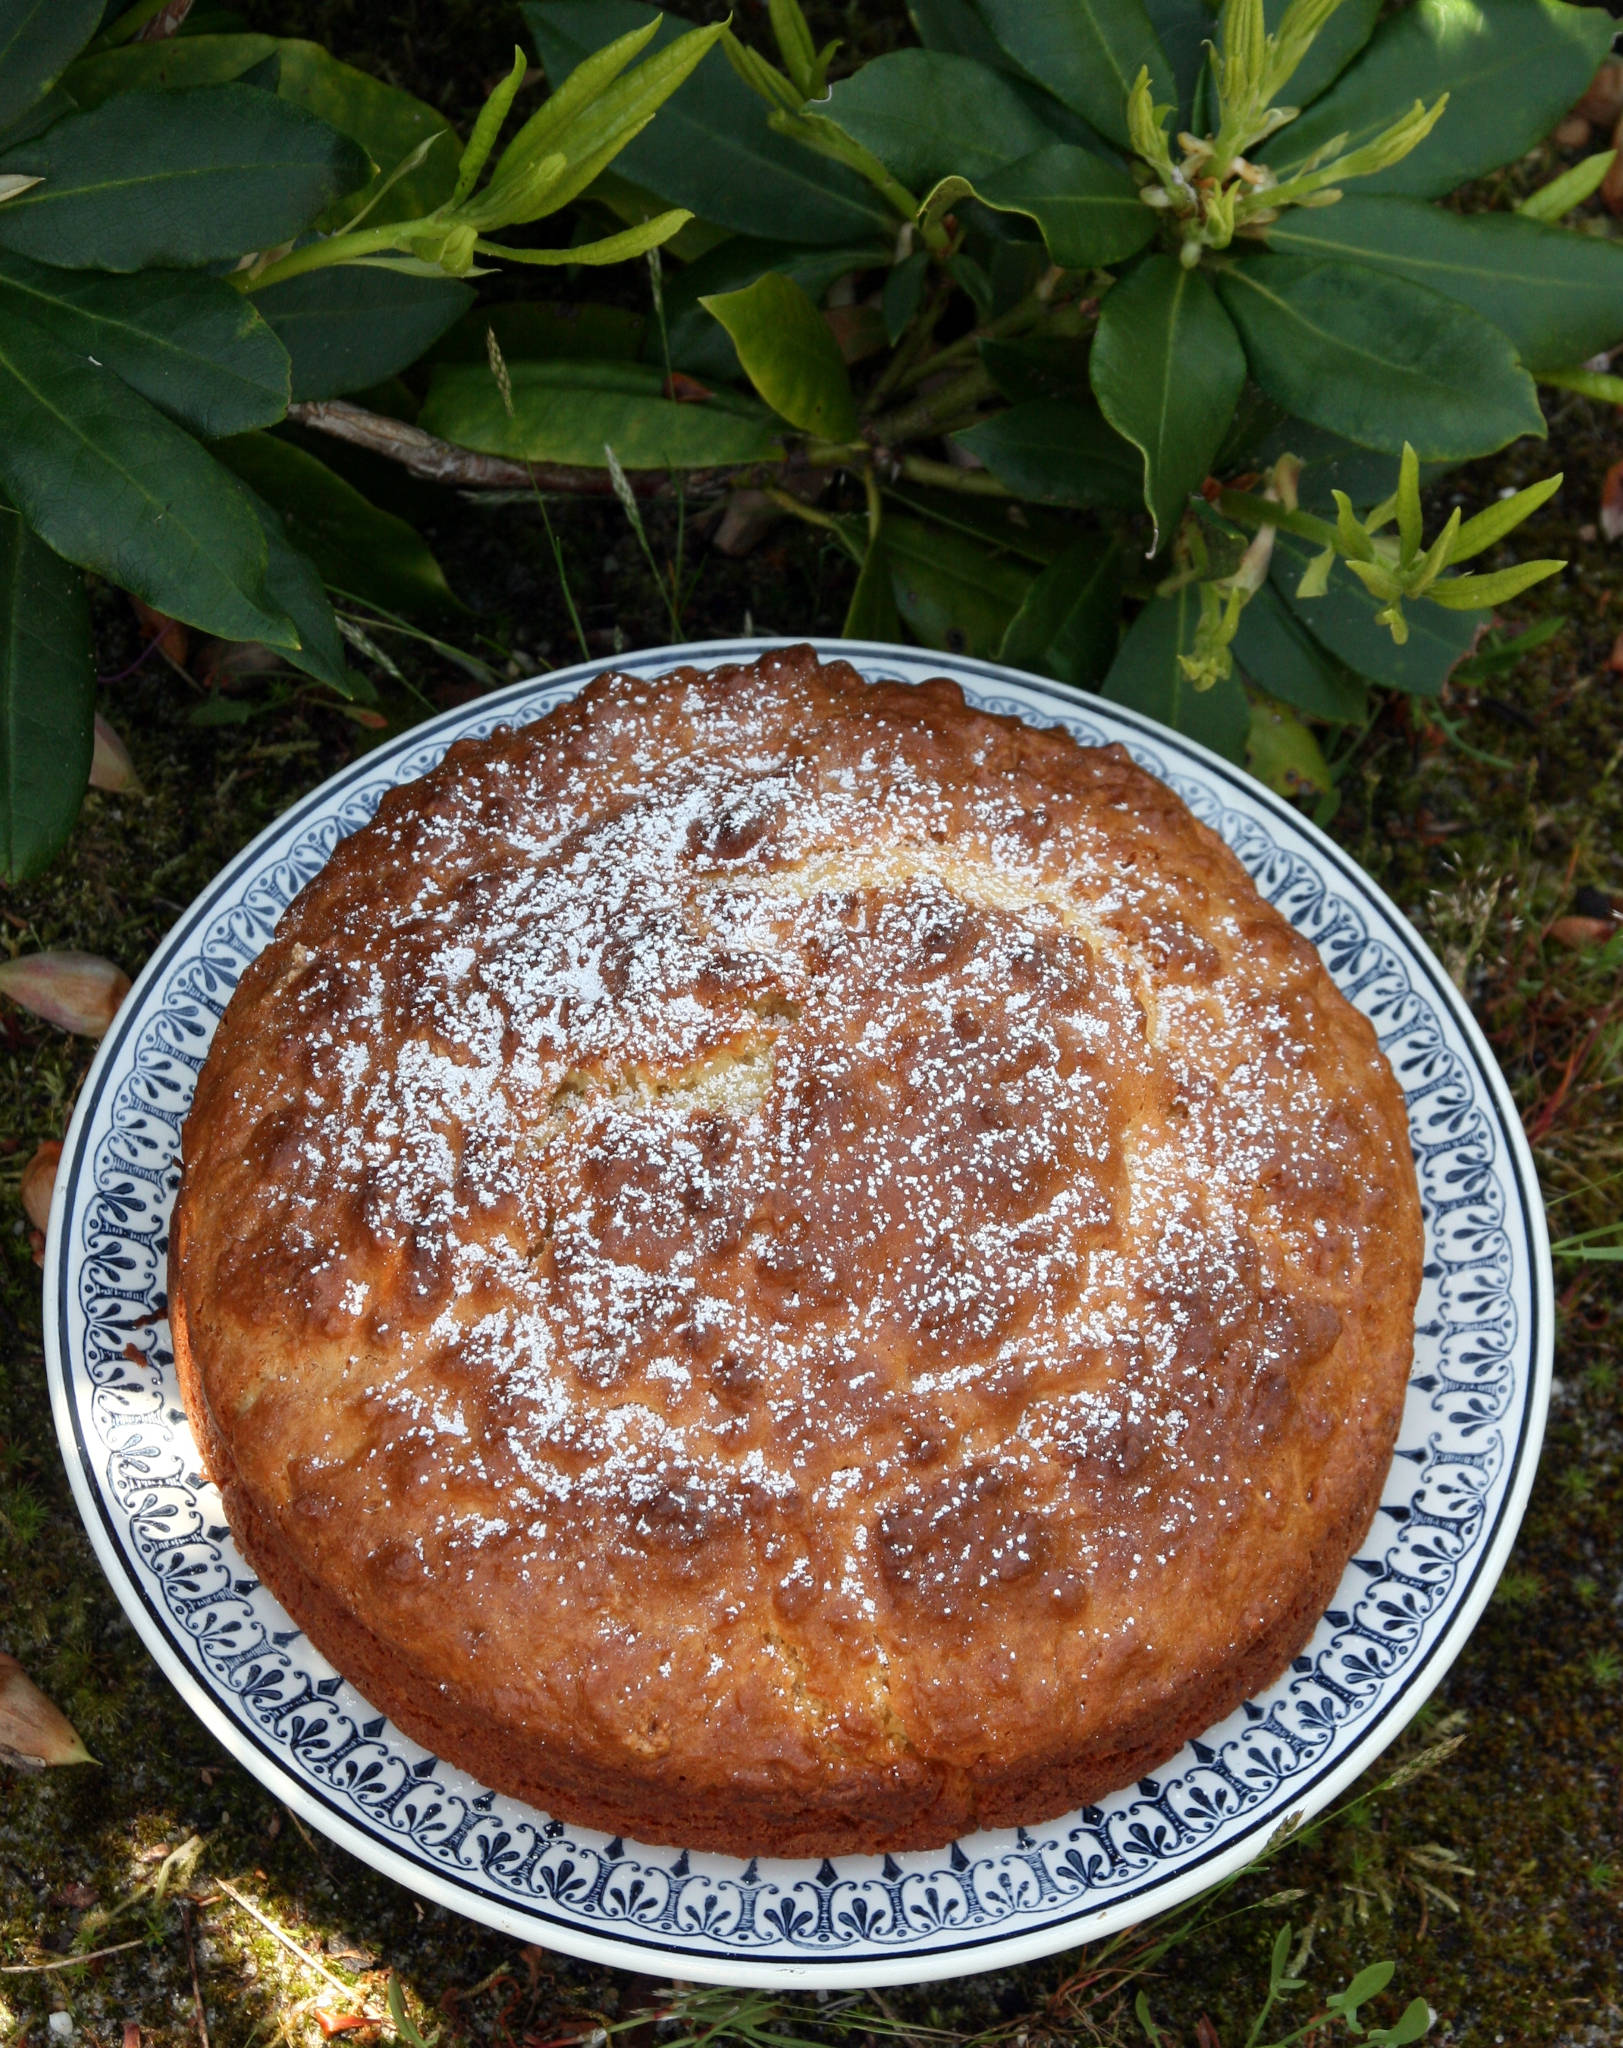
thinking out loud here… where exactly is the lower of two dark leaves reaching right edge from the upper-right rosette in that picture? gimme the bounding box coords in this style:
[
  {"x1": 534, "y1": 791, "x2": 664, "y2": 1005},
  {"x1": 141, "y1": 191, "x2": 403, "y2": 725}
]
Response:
[{"x1": 1268, "y1": 193, "x2": 1623, "y2": 371}]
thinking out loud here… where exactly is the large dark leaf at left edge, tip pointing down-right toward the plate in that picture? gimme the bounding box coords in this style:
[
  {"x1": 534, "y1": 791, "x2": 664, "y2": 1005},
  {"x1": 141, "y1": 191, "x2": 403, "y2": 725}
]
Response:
[{"x1": 0, "y1": 309, "x2": 297, "y2": 649}]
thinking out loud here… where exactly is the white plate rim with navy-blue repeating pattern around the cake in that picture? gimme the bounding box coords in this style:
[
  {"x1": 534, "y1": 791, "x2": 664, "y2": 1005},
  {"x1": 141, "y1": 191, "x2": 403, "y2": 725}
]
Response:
[{"x1": 45, "y1": 639, "x2": 1553, "y2": 1987}]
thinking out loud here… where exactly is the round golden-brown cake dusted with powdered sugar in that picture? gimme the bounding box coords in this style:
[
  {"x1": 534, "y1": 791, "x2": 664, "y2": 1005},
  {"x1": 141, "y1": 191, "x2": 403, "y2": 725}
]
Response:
[{"x1": 170, "y1": 647, "x2": 1420, "y2": 1855}]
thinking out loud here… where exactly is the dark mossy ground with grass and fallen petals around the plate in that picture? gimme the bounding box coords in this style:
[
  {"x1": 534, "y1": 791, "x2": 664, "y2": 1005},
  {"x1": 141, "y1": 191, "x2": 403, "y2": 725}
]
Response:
[{"x1": 0, "y1": 0, "x2": 1623, "y2": 2048}]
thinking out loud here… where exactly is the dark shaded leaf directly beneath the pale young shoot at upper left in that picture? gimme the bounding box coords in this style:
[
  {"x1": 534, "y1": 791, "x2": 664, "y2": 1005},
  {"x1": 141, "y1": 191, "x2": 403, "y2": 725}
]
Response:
[{"x1": 252, "y1": 264, "x2": 471, "y2": 403}]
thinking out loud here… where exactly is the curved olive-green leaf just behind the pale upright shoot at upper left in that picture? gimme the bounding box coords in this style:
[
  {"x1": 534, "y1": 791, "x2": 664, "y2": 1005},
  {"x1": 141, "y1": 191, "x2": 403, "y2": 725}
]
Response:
[{"x1": 277, "y1": 39, "x2": 461, "y2": 227}]
